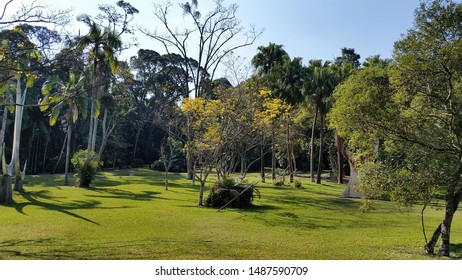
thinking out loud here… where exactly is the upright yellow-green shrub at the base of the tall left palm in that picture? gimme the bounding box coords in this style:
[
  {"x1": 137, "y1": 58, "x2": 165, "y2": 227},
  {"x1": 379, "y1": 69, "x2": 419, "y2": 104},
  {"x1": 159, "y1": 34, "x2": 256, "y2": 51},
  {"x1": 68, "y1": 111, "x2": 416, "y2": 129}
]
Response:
[{"x1": 71, "y1": 150, "x2": 103, "y2": 188}]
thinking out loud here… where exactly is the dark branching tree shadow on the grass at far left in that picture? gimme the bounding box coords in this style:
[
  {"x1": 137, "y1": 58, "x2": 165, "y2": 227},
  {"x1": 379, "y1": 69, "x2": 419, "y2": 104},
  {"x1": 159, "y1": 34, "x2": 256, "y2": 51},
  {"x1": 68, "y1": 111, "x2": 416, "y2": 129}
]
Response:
[{"x1": 9, "y1": 190, "x2": 127, "y2": 225}]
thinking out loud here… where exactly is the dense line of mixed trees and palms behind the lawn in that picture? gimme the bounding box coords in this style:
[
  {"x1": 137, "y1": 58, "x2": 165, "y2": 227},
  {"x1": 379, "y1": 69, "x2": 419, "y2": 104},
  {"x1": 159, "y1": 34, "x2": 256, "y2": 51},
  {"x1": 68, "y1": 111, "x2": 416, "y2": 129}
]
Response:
[{"x1": 0, "y1": 0, "x2": 462, "y2": 256}]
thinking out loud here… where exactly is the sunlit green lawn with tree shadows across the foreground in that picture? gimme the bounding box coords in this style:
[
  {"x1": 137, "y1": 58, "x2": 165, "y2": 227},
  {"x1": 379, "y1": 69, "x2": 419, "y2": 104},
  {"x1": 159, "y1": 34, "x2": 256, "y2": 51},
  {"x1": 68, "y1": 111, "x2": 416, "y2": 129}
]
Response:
[{"x1": 0, "y1": 169, "x2": 462, "y2": 260}]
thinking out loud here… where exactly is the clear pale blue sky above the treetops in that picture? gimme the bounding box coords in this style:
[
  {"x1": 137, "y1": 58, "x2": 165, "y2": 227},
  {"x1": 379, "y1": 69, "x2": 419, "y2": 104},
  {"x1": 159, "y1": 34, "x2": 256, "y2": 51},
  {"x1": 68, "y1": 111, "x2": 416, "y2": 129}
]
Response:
[{"x1": 7, "y1": 0, "x2": 419, "y2": 67}]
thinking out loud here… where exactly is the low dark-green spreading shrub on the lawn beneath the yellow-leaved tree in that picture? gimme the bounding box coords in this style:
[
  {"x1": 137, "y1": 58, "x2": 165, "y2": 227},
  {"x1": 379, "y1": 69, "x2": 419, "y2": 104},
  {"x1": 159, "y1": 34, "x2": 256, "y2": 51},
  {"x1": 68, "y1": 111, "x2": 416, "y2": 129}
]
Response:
[{"x1": 205, "y1": 179, "x2": 260, "y2": 208}]
